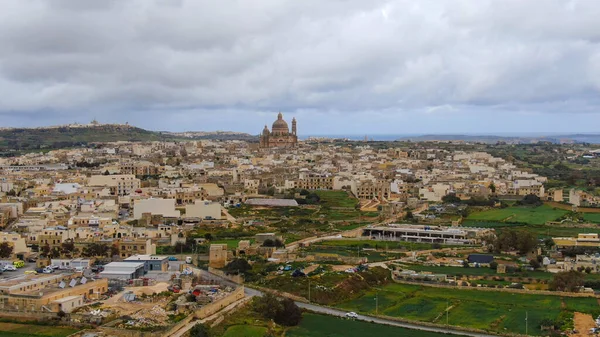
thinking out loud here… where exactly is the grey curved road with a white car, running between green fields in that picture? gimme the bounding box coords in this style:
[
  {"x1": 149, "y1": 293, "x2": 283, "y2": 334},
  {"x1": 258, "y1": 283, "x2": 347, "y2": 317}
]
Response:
[{"x1": 244, "y1": 286, "x2": 497, "y2": 337}]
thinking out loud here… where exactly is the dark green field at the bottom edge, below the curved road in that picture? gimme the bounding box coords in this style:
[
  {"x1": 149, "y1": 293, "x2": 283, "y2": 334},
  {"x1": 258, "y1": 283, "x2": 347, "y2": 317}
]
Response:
[{"x1": 285, "y1": 313, "x2": 468, "y2": 337}]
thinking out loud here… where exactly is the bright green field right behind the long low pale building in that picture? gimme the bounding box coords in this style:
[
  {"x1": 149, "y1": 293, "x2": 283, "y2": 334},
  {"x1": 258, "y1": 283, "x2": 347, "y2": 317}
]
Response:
[{"x1": 467, "y1": 205, "x2": 567, "y2": 225}]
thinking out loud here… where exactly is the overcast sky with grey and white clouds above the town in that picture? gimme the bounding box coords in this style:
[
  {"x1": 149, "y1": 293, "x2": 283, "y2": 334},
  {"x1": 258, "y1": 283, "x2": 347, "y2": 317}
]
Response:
[{"x1": 0, "y1": 0, "x2": 600, "y2": 135}]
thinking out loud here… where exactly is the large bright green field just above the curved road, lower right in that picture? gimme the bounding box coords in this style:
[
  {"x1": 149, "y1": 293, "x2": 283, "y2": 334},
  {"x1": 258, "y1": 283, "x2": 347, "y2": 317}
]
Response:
[{"x1": 339, "y1": 284, "x2": 600, "y2": 335}]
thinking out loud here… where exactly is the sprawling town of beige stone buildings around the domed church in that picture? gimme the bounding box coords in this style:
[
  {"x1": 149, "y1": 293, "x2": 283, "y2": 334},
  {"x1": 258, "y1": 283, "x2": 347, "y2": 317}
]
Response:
[{"x1": 0, "y1": 113, "x2": 600, "y2": 336}]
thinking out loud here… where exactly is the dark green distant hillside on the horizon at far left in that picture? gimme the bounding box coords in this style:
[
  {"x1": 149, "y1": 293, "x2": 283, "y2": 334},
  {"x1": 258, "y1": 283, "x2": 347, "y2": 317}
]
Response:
[{"x1": 0, "y1": 124, "x2": 173, "y2": 156}]
